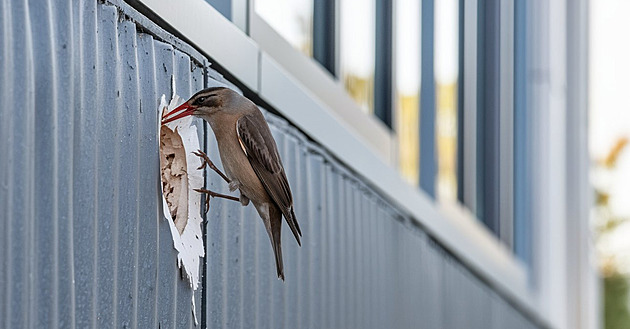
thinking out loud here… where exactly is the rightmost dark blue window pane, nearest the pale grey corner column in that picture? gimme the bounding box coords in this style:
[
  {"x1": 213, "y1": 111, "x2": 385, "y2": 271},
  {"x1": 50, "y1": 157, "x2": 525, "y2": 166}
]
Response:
[{"x1": 466, "y1": 0, "x2": 515, "y2": 248}]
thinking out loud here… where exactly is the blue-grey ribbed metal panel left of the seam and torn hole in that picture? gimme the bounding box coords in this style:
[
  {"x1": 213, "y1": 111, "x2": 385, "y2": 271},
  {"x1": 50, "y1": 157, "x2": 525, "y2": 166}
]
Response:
[{"x1": 0, "y1": 1, "x2": 205, "y2": 328}]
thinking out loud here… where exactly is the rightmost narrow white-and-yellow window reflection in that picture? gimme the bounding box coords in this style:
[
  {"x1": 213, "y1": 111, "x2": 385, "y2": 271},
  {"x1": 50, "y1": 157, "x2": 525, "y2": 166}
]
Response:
[{"x1": 435, "y1": 0, "x2": 459, "y2": 202}]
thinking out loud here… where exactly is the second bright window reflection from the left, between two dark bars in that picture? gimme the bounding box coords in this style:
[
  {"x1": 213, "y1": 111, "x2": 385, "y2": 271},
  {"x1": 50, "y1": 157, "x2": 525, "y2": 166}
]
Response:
[{"x1": 340, "y1": 0, "x2": 376, "y2": 113}]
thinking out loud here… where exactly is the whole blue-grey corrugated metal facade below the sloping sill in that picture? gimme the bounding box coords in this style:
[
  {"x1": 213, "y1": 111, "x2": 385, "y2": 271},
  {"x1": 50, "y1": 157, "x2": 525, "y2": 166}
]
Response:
[{"x1": 0, "y1": 0, "x2": 535, "y2": 329}]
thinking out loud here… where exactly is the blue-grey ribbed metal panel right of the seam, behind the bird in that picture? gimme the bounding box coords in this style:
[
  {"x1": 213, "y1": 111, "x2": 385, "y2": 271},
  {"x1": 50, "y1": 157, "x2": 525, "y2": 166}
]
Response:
[{"x1": 205, "y1": 105, "x2": 533, "y2": 329}]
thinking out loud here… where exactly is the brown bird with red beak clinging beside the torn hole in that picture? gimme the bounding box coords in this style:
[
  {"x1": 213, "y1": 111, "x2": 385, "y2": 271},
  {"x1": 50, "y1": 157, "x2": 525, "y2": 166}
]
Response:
[{"x1": 162, "y1": 87, "x2": 302, "y2": 281}]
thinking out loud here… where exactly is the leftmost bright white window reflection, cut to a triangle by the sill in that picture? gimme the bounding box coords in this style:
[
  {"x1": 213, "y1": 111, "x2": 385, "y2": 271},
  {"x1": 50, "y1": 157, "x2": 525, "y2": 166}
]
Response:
[{"x1": 255, "y1": 0, "x2": 313, "y2": 56}]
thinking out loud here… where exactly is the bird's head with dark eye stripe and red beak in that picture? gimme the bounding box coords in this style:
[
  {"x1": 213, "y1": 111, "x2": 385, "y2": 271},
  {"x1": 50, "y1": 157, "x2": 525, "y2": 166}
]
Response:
[{"x1": 162, "y1": 87, "x2": 239, "y2": 124}]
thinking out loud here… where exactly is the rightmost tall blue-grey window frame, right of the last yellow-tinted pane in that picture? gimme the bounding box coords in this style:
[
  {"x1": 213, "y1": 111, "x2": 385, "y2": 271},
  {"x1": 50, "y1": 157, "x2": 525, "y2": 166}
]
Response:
[{"x1": 457, "y1": 0, "x2": 523, "y2": 250}]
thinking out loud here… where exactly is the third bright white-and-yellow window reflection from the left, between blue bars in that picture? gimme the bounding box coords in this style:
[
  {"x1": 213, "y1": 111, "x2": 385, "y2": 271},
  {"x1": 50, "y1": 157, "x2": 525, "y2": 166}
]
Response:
[{"x1": 394, "y1": 0, "x2": 420, "y2": 185}]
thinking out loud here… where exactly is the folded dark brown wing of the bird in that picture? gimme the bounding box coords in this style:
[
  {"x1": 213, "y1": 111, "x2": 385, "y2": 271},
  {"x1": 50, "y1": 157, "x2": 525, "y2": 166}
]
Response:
[{"x1": 236, "y1": 112, "x2": 302, "y2": 244}]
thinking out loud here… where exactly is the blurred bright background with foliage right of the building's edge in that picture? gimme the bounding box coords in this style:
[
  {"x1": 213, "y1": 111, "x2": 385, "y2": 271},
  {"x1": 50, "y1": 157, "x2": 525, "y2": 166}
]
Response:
[{"x1": 589, "y1": 0, "x2": 630, "y2": 329}]
